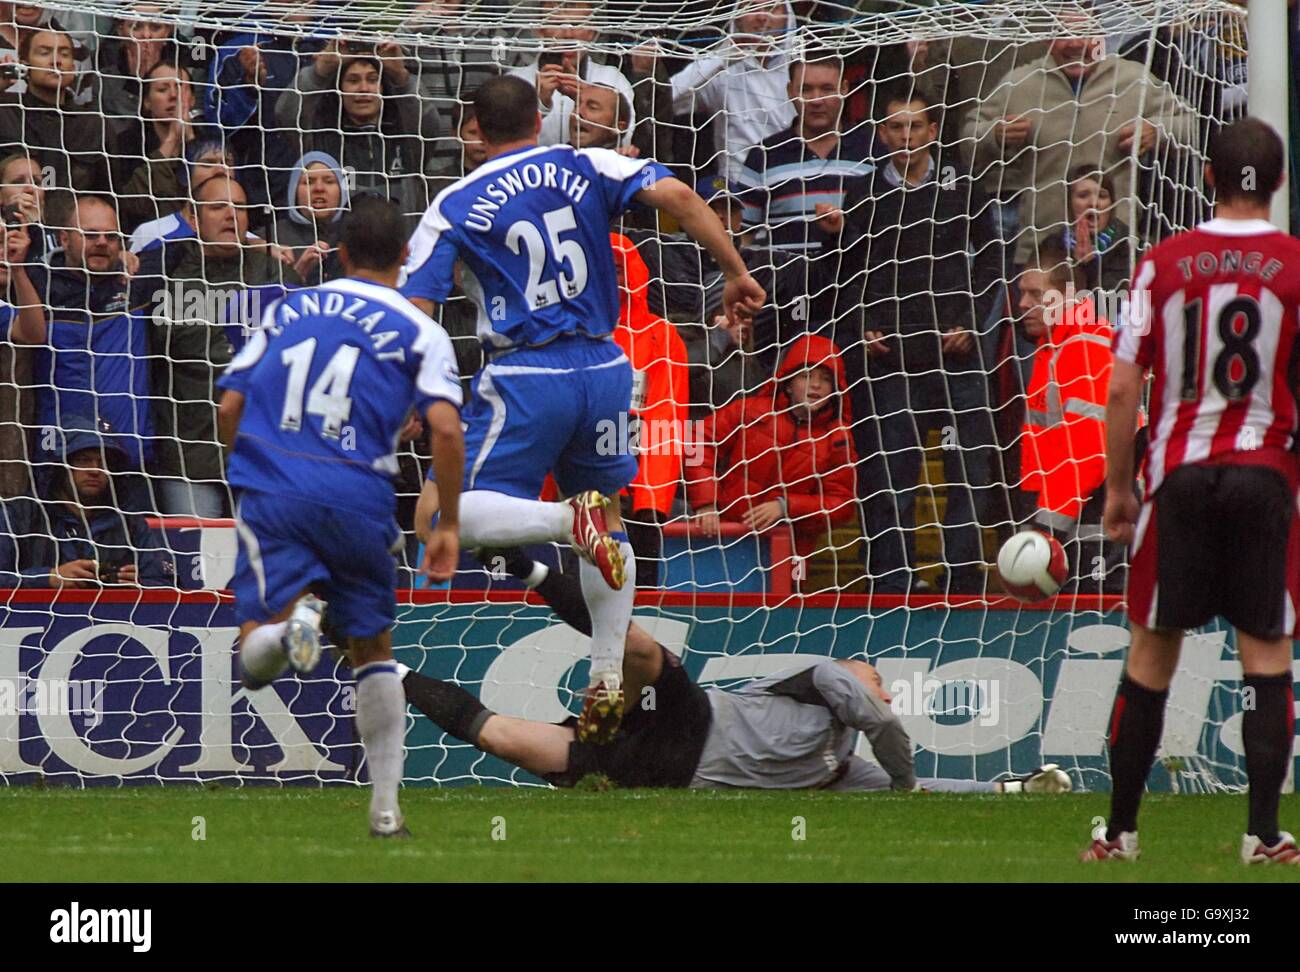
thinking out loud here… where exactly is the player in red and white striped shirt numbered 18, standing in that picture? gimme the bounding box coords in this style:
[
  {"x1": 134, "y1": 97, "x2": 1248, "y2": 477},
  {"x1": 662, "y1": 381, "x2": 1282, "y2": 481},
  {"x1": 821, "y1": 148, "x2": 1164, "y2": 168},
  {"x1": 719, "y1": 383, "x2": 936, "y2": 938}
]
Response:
[{"x1": 1083, "y1": 118, "x2": 1300, "y2": 864}]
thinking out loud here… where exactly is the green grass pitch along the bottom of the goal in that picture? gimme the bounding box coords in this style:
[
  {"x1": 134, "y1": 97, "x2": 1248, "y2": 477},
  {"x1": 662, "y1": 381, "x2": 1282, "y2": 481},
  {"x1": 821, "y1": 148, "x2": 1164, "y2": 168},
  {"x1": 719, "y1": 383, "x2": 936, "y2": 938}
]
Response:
[{"x1": 0, "y1": 787, "x2": 1300, "y2": 882}]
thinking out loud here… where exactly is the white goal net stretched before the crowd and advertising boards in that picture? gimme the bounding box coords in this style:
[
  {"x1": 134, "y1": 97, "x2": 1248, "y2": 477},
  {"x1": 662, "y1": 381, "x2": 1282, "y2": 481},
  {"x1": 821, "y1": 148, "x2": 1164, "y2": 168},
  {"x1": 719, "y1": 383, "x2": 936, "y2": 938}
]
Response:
[{"x1": 0, "y1": 0, "x2": 1268, "y2": 790}]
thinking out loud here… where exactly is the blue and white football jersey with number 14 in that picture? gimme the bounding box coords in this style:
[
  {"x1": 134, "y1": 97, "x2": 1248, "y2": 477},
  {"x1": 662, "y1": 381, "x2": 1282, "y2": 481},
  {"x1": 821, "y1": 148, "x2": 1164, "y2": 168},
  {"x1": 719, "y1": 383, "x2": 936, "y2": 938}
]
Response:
[{"x1": 218, "y1": 279, "x2": 462, "y2": 517}]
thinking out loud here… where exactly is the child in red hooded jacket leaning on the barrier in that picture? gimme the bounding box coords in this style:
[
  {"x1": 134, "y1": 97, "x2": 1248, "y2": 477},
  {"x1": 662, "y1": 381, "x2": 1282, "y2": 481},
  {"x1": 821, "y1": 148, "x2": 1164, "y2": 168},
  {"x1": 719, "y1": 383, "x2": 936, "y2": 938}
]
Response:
[{"x1": 686, "y1": 334, "x2": 858, "y2": 556}]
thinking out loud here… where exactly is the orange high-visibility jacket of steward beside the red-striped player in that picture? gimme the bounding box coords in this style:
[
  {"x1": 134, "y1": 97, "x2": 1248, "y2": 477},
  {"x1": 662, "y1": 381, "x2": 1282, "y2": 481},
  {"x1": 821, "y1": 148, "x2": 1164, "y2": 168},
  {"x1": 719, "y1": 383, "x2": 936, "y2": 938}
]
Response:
[{"x1": 1021, "y1": 300, "x2": 1114, "y2": 530}]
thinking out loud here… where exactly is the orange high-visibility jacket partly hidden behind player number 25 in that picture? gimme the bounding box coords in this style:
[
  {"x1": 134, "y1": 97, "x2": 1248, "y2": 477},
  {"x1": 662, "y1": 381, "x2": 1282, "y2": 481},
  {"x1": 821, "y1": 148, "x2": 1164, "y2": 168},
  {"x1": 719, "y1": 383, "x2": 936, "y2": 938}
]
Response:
[{"x1": 610, "y1": 233, "x2": 690, "y2": 517}]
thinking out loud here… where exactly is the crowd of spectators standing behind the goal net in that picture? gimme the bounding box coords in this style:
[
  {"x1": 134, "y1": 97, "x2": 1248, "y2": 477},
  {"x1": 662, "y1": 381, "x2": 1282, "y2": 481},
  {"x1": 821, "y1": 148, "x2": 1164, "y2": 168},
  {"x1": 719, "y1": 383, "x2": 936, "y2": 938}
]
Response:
[{"x1": 0, "y1": 0, "x2": 1235, "y2": 593}]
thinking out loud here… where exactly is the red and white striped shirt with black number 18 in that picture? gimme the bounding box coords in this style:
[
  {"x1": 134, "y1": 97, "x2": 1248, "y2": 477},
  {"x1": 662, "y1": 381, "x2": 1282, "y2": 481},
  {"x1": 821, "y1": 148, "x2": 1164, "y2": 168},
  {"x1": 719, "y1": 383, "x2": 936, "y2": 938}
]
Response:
[{"x1": 1114, "y1": 218, "x2": 1300, "y2": 496}]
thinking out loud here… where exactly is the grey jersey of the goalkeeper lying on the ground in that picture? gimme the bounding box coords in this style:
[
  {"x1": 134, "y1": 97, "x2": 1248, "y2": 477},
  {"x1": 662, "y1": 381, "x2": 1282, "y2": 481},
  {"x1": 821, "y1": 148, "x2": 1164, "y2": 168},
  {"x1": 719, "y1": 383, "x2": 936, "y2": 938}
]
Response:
[{"x1": 690, "y1": 659, "x2": 917, "y2": 790}]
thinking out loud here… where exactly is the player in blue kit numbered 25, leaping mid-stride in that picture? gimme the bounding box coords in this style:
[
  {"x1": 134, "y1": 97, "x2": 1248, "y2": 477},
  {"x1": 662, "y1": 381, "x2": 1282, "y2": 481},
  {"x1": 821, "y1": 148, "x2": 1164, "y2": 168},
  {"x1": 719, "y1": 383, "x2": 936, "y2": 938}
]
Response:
[{"x1": 402, "y1": 75, "x2": 766, "y2": 742}]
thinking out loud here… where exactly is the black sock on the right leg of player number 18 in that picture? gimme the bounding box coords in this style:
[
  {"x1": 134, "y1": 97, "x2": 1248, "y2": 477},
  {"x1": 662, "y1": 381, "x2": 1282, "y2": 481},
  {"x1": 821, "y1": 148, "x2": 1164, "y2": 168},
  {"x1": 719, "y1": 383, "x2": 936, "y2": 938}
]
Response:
[{"x1": 1242, "y1": 673, "x2": 1295, "y2": 847}]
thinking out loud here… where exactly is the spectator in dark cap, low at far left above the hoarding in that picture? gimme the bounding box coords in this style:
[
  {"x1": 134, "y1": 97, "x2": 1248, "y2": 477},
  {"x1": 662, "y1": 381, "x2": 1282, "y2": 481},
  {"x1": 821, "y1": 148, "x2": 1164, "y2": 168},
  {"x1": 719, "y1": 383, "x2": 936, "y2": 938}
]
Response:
[{"x1": 0, "y1": 417, "x2": 176, "y2": 587}]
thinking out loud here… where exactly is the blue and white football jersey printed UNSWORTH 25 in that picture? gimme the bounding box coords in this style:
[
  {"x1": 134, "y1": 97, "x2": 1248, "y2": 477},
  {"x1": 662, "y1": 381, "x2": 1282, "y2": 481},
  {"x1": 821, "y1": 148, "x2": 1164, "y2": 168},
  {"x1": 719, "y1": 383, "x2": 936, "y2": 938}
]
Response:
[{"x1": 402, "y1": 146, "x2": 672, "y2": 348}]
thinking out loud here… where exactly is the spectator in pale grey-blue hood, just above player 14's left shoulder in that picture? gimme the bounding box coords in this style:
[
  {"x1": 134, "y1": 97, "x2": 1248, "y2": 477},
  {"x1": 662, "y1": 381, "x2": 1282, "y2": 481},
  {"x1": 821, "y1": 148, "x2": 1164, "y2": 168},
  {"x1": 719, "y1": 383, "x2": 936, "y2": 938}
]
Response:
[{"x1": 276, "y1": 152, "x2": 351, "y2": 286}]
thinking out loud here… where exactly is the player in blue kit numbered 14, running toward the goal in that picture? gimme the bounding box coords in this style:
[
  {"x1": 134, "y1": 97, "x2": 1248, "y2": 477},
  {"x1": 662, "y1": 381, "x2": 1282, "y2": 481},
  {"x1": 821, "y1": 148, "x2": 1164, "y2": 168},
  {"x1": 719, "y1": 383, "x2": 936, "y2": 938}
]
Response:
[{"x1": 220, "y1": 199, "x2": 464, "y2": 837}]
